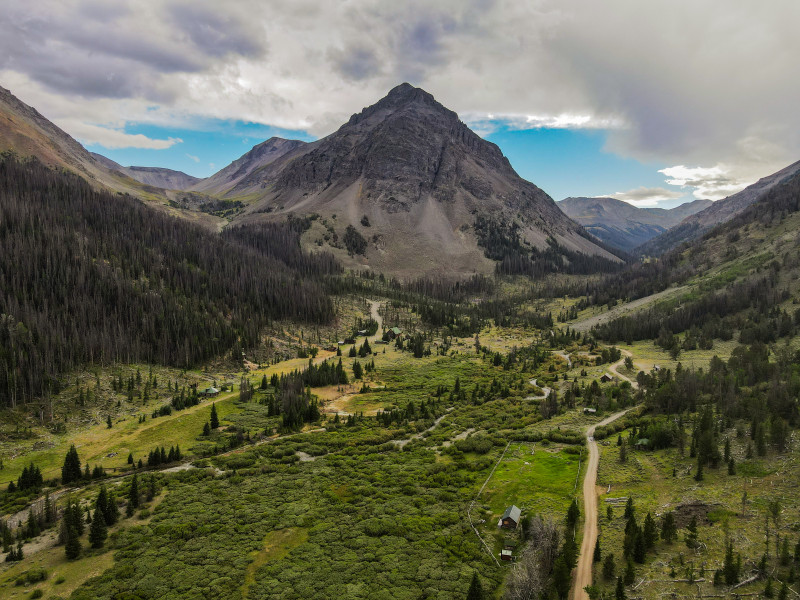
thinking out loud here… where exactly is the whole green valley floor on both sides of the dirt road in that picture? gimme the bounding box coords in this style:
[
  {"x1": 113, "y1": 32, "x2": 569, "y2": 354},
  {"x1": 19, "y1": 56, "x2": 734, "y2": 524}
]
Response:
[{"x1": 0, "y1": 302, "x2": 800, "y2": 600}]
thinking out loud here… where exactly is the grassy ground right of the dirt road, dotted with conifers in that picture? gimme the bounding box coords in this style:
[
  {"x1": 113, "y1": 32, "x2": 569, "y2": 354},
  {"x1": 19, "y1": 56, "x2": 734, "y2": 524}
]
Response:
[{"x1": 595, "y1": 422, "x2": 800, "y2": 599}]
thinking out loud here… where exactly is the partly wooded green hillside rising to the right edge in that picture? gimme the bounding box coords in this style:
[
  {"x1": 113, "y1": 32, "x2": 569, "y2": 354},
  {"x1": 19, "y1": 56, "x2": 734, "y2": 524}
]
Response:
[{"x1": 595, "y1": 166, "x2": 800, "y2": 352}]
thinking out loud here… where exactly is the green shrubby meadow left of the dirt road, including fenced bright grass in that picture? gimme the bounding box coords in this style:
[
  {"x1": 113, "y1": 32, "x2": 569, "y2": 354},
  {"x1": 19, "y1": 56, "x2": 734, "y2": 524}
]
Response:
[{"x1": 0, "y1": 316, "x2": 600, "y2": 600}]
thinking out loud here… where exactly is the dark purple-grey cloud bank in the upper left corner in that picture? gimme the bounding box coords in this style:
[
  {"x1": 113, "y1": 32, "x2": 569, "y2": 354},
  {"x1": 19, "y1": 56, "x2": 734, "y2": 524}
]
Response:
[{"x1": 0, "y1": 1, "x2": 266, "y2": 102}]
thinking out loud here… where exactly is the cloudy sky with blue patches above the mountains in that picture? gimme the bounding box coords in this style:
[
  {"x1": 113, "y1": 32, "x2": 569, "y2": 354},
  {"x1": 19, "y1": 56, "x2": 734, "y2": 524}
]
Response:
[{"x1": 0, "y1": 0, "x2": 800, "y2": 207}]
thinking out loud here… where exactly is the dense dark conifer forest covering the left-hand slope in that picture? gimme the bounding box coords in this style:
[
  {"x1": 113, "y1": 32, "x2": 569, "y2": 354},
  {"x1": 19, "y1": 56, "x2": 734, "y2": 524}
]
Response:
[{"x1": 0, "y1": 156, "x2": 339, "y2": 406}]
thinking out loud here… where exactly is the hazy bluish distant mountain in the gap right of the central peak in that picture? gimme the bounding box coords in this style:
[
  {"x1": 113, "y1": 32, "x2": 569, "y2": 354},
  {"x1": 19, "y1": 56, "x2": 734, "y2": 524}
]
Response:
[{"x1": 557, "y1": 198, "x2": 713, "y2": 252}]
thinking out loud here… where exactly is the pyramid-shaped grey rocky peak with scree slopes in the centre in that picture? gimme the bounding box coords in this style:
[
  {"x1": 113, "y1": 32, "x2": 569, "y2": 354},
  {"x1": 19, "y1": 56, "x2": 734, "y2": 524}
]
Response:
[{"x1": 216, "y1": 83, "x2": 617, "y2": 276}]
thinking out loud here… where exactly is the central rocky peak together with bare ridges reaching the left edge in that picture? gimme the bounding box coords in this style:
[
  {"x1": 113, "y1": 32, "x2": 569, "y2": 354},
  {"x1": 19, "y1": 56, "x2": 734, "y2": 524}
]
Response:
[{"x1": 0, "y1": 83, "x2": 620, "y2": 277}]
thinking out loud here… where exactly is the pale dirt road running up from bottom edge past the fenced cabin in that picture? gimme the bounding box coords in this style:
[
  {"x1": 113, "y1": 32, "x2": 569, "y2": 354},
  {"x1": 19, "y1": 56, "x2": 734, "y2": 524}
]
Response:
[{"x1": 570, "y1": 408, "x2": 631, "y2": 600}]
